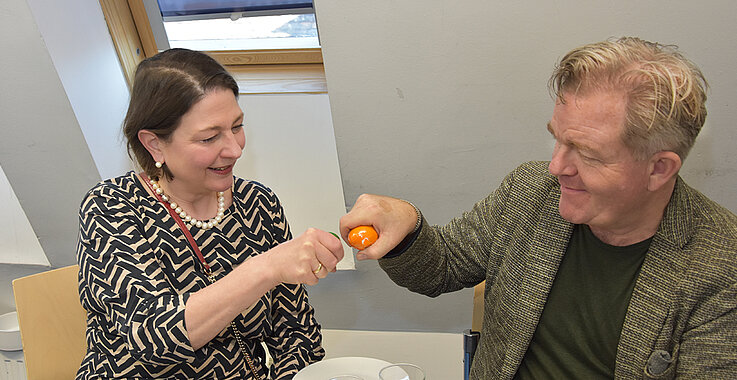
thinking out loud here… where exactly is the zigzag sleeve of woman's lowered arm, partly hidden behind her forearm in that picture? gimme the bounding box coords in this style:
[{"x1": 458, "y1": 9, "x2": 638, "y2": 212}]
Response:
[{"x1": 258, "y1": 185, "x2": 325, "y2": 380}]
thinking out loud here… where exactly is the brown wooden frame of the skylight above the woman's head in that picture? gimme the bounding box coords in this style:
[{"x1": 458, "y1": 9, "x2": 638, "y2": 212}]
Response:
[{"x1": 99, "y1": 0, "x2": 327, "y2": 93}]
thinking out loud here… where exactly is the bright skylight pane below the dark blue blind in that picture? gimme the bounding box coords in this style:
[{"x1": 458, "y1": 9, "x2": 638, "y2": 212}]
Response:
[{"x1": 164, "y1": 13, "x2": 320, "y2": 50}]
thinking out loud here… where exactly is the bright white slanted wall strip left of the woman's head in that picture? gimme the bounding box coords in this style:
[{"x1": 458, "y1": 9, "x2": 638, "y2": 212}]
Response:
[{"x1": 27, "y1": 0, "x2": 133, "y2": 178}]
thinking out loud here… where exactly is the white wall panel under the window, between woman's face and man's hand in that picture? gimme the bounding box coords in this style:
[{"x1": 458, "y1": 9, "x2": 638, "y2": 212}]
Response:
[{"x1": 233, "y1": 94, "x2": 355, "y2": 269}]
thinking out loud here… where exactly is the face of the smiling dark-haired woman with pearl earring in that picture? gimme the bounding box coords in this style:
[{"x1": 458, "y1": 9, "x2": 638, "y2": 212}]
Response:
[{"x1": 159, "y1": 89, "x2": 246, "y2": 197}]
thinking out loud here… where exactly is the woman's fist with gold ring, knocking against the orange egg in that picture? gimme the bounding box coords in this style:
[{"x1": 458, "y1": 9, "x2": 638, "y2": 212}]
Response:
[{"x1": 257, "y1": 228, "x2": 343, "y2": 285}]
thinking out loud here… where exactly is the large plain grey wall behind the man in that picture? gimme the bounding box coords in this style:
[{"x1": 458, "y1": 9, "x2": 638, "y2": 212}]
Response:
[{"x1": 315, "y1": 0, "x2": 737, "y2": 332}]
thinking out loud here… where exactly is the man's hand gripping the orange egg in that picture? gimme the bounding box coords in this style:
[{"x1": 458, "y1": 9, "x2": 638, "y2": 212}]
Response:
[{"x1": 340, "y1": 194, "x2": 417, "y2": 260}]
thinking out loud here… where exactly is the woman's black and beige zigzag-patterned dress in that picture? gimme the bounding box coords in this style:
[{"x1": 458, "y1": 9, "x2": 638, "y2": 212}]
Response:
[{"x1": 77, "y1": 172, "x2": 325, "y2": 379}]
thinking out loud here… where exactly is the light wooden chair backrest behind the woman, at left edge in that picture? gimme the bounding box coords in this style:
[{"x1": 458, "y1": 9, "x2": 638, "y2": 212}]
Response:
[{"x1": 13, "y1": 265, "x2": 87, "y2": 380}]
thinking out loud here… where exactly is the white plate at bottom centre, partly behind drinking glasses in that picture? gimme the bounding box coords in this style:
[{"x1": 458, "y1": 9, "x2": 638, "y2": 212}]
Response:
[{"x1": 294, "y1": 357, "x2": 392, "y2": 380}]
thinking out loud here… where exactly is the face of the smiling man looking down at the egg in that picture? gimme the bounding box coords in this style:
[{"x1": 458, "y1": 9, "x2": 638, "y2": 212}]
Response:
[{"x1": 548, "y1": 91, "x2": 648, "y2": 233}]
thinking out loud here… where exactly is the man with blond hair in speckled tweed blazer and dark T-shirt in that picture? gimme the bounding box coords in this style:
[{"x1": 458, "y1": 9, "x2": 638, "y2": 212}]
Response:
[{"x1": 341, "y1": 38, "x2": 737, "y2": 379}]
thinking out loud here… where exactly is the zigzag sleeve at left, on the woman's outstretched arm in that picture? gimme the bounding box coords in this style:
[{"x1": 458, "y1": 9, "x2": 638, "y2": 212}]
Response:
[{"x1": 77, "y1": 185, "x2": 195, "y2": 365}]
